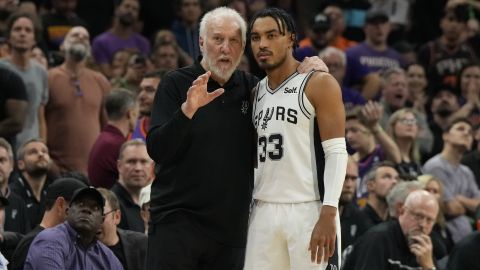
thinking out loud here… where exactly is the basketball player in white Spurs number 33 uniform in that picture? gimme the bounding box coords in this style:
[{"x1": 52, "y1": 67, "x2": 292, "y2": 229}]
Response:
[{"x1": 245, "y1": 8, "x2": 348, "y2": 270}]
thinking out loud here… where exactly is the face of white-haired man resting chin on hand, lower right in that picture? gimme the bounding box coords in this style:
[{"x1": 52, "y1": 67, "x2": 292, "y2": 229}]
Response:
[{"x1": 399, "y1": 199, "x2": 438, "y2": 235}]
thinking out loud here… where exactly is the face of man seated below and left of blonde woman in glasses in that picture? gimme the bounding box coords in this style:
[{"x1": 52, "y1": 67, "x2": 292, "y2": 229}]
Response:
[{"x1": 367, "y1": 167, "x2": 400, "y2": 199}]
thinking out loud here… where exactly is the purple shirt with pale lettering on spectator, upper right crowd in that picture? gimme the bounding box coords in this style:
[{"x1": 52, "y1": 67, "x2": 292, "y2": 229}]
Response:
[{"x1": 343, "y1": 42, "x2": 403, "y2": 86}]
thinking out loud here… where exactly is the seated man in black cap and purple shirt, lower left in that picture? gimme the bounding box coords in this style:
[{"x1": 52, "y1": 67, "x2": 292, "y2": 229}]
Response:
[{"x1": 24, "y1": 187, "x2": 123, "y2": 270}]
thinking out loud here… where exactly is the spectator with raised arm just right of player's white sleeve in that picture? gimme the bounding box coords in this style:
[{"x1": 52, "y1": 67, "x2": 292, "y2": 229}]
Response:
[{"x1": 345, "y1": 101, "x2": 401, "y2": 202}]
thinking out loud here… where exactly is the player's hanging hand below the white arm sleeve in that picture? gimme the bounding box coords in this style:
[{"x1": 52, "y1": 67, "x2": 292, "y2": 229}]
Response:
[{"x1": 308, "y1": 205, "x2": 337, "y2": 264}]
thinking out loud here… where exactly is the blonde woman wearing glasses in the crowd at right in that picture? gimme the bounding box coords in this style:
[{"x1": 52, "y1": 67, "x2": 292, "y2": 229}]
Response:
[{"x1": 387, "y1": 108, "x2": 422, "y2": 180}]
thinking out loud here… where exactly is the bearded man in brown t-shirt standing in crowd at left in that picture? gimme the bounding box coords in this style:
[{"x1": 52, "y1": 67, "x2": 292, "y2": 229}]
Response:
[{"x1": 45, "y1": 26, "x2": 110, "y2": 174}]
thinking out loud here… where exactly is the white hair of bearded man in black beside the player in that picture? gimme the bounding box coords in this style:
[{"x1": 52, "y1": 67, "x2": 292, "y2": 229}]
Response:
[{"x1": 200, "y1": 7, "x2": 247, "y2": 45}]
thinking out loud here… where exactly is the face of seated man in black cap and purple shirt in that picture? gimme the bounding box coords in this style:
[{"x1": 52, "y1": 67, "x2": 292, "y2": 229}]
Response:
[{"x1": 67, "y1": 195, "x2": 103, "y2": 234}]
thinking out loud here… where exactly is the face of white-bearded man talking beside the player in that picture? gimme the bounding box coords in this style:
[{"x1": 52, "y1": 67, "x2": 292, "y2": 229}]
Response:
[{"x1": 200, "y1": 18, "x2": 245, "y2": 81}]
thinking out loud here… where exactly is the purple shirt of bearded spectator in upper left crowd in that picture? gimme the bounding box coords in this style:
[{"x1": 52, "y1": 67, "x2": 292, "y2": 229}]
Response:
[{"x1": 92, "y1": 31, "x2": 150, "y2": 64}]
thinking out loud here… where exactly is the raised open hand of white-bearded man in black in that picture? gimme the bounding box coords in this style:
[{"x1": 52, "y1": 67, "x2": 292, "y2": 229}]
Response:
[{"x1": 182, "y1": 71, "x2": 225, "y2": 119}]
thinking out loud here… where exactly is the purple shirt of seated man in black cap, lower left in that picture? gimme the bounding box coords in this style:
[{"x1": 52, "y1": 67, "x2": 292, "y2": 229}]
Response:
[{"x1": 24, "y1": 222, "x2": 123, "y2": 270}]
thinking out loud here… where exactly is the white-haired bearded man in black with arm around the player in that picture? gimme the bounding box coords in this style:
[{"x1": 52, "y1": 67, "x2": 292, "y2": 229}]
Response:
[{"x1": 146, "y1": 4, "x2": 326, "y2": 270}]
